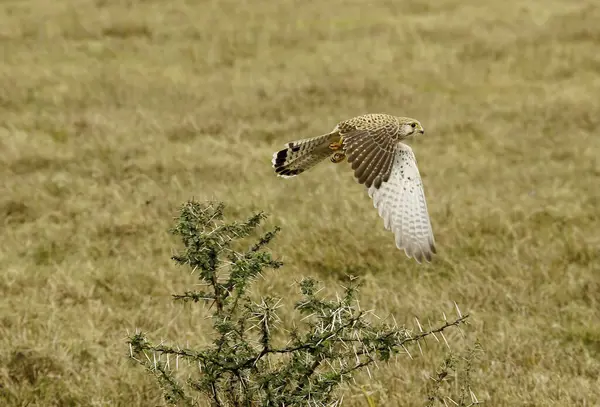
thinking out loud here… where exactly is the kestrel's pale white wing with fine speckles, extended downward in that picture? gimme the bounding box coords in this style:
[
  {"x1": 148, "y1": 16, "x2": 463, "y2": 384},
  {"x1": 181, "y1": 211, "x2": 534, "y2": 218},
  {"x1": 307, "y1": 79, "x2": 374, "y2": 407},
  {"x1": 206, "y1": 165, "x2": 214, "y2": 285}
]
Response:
[{"x1": 368, "y1": 143, "x2": 436, "y2": 263}]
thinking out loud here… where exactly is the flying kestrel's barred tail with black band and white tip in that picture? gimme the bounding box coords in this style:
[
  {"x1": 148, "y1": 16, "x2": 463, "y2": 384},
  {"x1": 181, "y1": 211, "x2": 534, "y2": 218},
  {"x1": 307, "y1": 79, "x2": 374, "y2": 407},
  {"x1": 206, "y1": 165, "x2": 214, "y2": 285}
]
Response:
[{"x1": 272, "y1": 133, "x2": 339, "y2": 178}]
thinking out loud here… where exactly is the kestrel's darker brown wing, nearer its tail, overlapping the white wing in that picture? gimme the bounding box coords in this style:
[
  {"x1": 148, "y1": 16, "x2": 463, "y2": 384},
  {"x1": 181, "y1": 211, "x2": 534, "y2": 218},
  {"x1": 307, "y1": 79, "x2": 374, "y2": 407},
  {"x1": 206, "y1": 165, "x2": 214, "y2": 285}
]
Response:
[{"x1": 340, "y1": 126, "x2": 398, "y2": 188}]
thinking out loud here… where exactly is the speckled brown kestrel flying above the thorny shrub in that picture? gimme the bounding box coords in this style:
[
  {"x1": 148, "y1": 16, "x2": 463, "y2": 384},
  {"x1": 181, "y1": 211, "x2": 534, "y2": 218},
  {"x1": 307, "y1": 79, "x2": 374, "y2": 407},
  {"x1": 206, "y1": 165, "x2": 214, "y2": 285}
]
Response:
[{"x1": 272, "y1": 114, "x2": 436, "y2": 263}]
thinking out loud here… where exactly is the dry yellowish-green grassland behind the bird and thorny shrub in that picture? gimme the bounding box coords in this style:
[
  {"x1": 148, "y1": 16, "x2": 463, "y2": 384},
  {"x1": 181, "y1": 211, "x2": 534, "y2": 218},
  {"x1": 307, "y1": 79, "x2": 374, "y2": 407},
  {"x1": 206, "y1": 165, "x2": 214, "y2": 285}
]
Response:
[{"x1": 0, "y1": 0, "x2": 600, "y2": 406}]
